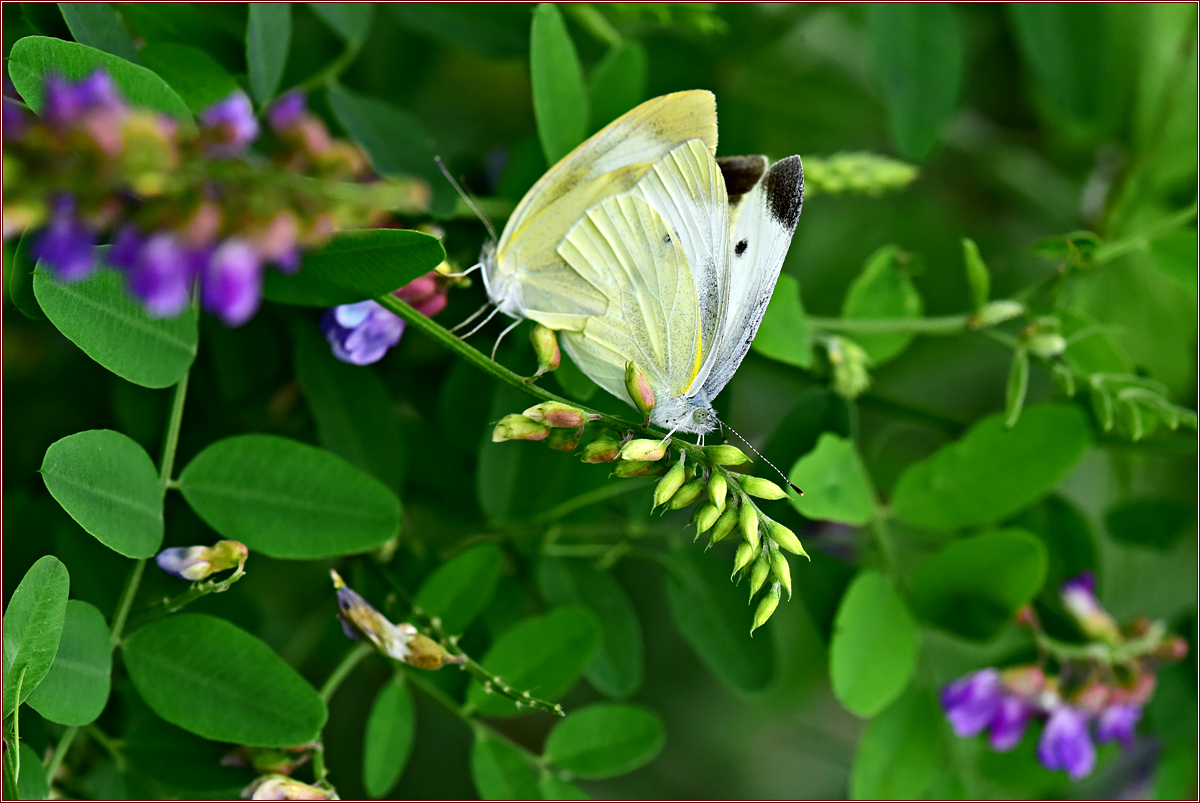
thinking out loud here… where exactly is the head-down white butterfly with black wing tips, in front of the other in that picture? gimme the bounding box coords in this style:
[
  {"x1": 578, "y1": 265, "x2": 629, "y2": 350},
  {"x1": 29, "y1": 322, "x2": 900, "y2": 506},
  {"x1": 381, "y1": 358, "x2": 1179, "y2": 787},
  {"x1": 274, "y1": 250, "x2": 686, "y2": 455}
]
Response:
[{"x1": 557, "y1": 139, "x2": 804, "y2": 437}]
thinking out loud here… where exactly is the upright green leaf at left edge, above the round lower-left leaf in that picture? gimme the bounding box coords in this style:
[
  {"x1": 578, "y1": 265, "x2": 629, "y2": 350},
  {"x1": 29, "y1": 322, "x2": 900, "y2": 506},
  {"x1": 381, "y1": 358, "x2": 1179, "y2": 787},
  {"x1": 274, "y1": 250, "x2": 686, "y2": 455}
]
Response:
[{"x1": 4, "y1": 555, "x2": 71, "y2": 718}]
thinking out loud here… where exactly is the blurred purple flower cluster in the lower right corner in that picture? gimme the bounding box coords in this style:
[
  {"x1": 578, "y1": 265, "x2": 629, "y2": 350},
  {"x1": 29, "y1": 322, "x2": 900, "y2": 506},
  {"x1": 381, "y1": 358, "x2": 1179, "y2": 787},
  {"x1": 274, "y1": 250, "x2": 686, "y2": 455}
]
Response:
[{"x1": 941, "y1": 573, "x2": 1187, "y2": 780}]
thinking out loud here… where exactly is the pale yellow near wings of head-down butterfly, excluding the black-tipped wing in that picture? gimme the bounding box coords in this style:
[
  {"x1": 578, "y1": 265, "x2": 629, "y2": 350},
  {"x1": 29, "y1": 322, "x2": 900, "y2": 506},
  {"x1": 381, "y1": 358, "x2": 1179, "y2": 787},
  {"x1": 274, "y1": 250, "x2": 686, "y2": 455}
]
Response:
[{"x1": 558, "y1": 140, "x2": 728, "y2": 425}]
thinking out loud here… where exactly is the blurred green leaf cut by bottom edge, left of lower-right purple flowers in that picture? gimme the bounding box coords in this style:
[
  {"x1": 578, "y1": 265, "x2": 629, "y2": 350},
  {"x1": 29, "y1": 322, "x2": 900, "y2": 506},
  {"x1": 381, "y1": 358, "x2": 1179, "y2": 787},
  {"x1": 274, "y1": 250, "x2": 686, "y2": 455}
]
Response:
[{"x1": 850, "y1": 685, "x2": 946, "y2": 801}]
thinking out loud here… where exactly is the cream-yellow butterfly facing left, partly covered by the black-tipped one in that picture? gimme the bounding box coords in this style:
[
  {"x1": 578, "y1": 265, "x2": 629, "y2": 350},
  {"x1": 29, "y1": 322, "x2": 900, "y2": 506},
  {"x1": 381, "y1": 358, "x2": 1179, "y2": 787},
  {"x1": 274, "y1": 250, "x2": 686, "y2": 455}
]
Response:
[{"x1": 484, "y1": 90, "x2": 716, "y2": 330}]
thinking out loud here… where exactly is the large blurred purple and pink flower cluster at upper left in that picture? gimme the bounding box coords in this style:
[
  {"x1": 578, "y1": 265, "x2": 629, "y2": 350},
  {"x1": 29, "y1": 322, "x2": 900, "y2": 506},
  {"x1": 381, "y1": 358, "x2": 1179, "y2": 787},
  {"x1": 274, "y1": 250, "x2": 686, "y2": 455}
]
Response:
[{"x1": 4, "y1": 70, "x2": 428, "y2": 326}]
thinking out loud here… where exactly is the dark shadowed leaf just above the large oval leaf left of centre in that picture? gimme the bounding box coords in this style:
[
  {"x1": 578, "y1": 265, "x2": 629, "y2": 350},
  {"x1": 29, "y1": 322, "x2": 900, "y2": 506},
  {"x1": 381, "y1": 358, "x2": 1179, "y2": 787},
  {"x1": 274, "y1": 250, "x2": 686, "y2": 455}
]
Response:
[{"x1": 295, "y1": 324, "x2": 407, "y2": 493}]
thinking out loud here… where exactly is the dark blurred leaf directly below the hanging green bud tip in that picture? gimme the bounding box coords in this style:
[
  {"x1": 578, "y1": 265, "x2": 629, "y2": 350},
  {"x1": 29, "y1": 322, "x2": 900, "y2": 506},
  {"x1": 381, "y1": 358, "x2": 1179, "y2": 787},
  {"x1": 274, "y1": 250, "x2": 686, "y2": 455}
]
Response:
[{"x1": 666, "y1": 549, "x2": 775, "y2": 691}]
